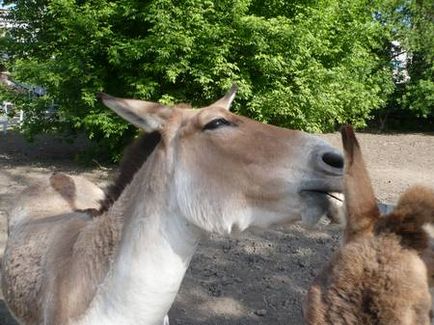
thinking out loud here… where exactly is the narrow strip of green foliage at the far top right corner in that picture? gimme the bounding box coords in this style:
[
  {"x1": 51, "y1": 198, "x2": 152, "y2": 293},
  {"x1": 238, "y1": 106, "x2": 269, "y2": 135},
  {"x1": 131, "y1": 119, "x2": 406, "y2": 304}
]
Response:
[{"x1": 376, "y1": 0, "x2": 434, "y2": 118}]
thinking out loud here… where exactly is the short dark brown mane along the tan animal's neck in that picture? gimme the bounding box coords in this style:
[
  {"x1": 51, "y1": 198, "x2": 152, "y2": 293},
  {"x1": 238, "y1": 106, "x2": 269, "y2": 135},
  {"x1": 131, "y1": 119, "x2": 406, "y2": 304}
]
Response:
[{"x1": 97, "y1": 132, "x2": 161, "y2": 214}]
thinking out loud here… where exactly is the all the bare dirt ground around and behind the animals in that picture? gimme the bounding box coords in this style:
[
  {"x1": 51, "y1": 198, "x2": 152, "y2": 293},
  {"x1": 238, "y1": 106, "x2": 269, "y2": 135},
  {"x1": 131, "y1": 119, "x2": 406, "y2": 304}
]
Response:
[{"x1": 0, "y1": 133, "x2": 434, "y2": 325}]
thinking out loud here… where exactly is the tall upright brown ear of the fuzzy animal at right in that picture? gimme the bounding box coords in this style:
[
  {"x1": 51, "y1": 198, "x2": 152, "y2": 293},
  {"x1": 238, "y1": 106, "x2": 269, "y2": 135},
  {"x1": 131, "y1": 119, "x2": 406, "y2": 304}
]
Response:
[{"x1": 341, "y1": 126, "x2": 380, "y2": 241}]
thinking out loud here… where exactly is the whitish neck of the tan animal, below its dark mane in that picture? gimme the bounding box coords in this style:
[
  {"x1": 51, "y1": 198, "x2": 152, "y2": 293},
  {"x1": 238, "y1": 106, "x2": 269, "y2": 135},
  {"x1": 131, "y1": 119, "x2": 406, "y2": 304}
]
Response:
[{"x1": 80, "y1": 148, "x2": 202, "y2": 324}]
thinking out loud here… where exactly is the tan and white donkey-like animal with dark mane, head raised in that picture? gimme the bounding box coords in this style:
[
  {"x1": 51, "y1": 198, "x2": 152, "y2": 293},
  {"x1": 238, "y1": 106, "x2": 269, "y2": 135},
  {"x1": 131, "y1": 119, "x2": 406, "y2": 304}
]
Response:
[{"x1": 2, "y1": 85, "x2": 343, "y2": 325}]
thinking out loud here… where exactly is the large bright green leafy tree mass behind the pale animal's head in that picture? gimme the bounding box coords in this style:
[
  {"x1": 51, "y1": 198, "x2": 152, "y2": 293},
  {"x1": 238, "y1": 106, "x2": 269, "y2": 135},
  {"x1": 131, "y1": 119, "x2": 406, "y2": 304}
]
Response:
[{"x1": 0, "y1": 0, "x2": 408, "y2": 157}]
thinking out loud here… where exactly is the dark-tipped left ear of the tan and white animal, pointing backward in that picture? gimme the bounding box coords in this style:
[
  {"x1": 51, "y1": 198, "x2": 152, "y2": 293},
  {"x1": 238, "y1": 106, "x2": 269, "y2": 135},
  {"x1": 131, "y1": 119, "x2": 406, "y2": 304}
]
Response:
[{"x1": 98, "y1": 93, "x2": 173, "y2": 132}]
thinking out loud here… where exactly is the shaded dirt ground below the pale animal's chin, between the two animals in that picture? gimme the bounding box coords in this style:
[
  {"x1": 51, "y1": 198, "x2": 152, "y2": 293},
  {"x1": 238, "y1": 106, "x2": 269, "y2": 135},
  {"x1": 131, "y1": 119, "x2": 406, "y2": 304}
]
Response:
[{"x1": 169, "y1": 225, "x2": 340, "y2": 325}]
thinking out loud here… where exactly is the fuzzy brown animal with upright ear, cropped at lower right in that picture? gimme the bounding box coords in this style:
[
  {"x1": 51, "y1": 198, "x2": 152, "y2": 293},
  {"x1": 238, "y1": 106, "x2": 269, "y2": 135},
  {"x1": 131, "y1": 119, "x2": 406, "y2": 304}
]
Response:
[{"x1": 304, "y1": 127, "x2": 434, "y2": 325}]
